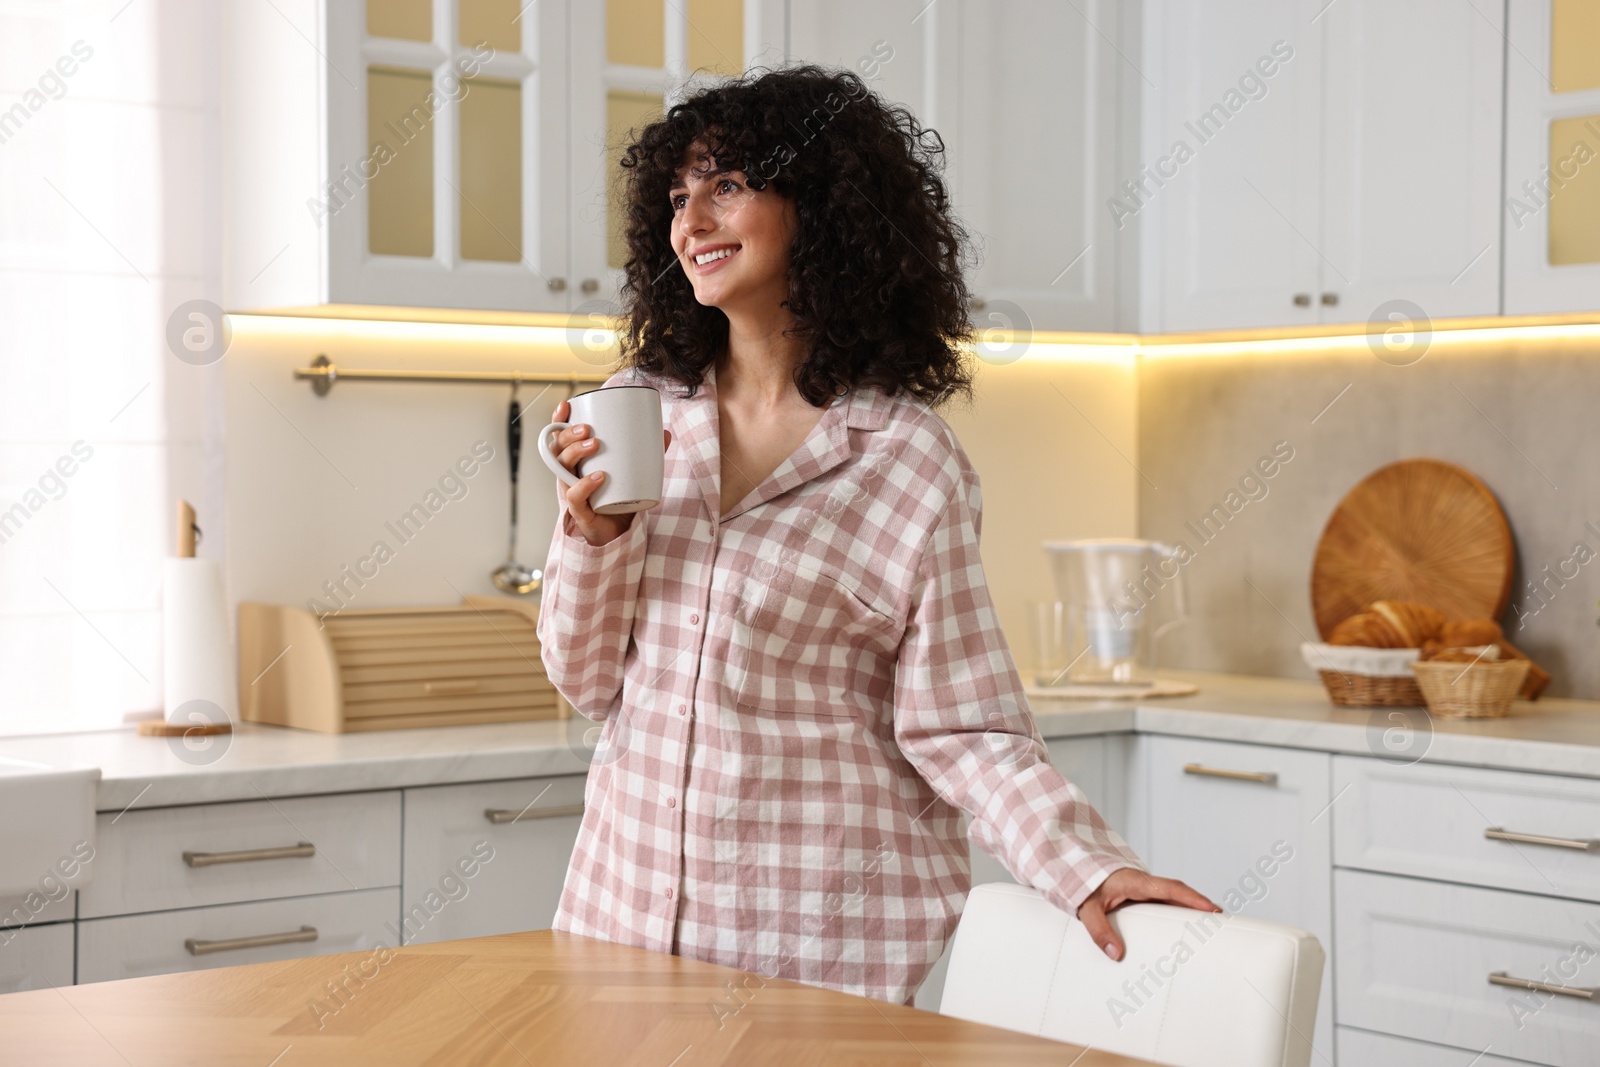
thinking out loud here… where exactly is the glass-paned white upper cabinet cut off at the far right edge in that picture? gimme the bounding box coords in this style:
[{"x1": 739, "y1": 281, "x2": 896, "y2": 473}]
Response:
[{"x1": 1504, "y1": 0, "x2": 1600, "y2": 315}]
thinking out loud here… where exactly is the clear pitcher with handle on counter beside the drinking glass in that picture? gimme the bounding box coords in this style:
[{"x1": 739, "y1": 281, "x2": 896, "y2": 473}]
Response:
[{"x1": 1045, "y1": 539, "x2": 1189, "y2": 686}]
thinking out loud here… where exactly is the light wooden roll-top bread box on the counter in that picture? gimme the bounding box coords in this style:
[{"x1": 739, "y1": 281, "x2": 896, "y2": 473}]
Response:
[{"x1": 238, "y1": 597, "x2": 571, "y2": 734}]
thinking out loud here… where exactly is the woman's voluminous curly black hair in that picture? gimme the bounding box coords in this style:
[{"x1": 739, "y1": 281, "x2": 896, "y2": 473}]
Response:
[{"x1": 608, "y1": 66, "x2": 973, "y2": 406}]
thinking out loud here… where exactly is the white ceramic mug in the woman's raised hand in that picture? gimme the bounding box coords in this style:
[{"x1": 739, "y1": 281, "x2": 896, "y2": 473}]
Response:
[{"x1": 539, "y1": 386, "x2": 666, "y2": 515}]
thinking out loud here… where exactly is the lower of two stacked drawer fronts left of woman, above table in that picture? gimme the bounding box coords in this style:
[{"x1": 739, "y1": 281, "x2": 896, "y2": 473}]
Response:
[{"x1": 78, "y1": 889, "x2": 400, "y2": 982}]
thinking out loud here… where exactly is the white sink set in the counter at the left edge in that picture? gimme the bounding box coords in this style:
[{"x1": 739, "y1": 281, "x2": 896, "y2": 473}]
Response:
[{"x1": 0, "y1": 757, "x2": 101, "y2": 897}]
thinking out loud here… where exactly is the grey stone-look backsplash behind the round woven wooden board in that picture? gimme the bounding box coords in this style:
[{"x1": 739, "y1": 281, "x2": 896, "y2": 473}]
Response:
[{"x1": 1139, "y1": 333, "x2": 1600, "y2": 699}]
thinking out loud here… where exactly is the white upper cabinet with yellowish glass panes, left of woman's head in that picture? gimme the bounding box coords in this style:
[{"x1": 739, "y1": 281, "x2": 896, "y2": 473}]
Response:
[{"x1": 224, "y1": 0, "x2": 787, "y2": 314}]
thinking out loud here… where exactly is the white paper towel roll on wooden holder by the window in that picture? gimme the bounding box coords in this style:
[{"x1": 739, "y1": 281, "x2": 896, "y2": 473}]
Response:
[{"x1": 162, "y1": 558, "x2": 238, "y2": 726}]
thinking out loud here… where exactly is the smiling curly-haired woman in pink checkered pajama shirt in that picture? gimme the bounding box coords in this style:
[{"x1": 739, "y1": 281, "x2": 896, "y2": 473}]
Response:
[{"x1": 539, "y1": 67, "x2": 1218, "y2": 1003}]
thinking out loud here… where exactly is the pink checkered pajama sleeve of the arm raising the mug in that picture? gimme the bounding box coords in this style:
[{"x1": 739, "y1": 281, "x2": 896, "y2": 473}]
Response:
[{"x1": 538, "y1": 507, "x2": 650, "y2": 720}]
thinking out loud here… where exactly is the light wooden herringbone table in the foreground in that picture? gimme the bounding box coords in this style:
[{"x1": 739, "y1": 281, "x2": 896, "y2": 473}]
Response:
[{"x1": 0, "y1": 929, "x2": 1149, "y2": 1067}]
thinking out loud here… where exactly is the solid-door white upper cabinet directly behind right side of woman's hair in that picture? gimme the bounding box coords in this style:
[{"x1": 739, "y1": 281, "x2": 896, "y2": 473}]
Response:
[{"x1": 790, "y1": 0, "x2": 1136, "y2": 333}]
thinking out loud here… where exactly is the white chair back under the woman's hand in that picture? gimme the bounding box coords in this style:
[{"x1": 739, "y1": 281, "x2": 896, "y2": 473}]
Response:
[{"x1": 939, "y1": 883, "x2": 1323, "y2": 1067}]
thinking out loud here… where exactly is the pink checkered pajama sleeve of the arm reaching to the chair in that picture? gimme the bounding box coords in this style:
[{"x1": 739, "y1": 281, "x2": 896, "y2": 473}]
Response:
[{"x1": 894, "y1": 446, "x2": 1146, "y2": 913}]
